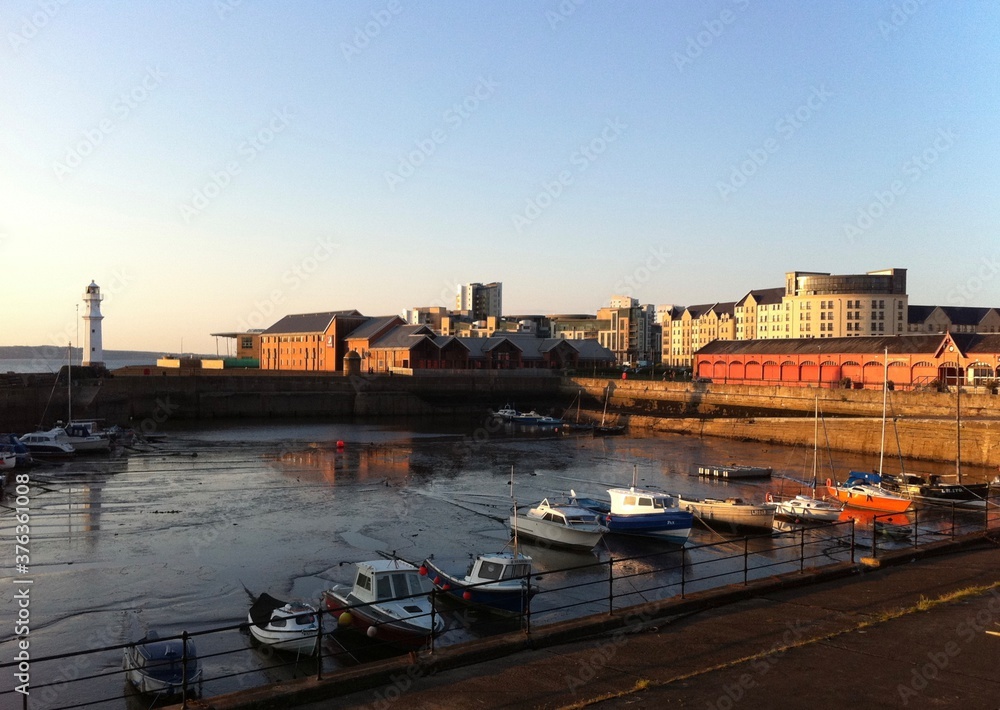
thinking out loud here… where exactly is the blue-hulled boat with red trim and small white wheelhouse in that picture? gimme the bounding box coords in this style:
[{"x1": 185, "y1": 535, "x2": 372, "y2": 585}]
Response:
[{"x1": 420, "y1": 551, "x2": 538, "y2": 614}]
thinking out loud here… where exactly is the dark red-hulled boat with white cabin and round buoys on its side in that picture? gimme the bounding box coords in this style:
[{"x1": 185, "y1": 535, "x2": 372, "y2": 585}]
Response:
[{"x1": 323, "y1": 559, "x2": 444, "y2": 651}]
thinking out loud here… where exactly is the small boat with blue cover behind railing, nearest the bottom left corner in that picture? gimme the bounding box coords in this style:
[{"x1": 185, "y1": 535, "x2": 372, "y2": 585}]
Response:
[{"x1": 122, "y1": 631, "x2": 201, "y2": 696}]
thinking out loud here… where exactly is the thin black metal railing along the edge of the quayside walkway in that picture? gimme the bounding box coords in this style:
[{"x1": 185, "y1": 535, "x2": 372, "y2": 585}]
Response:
[{"x1": 0, "y1": 500, "x2": 1000, "y2": 710}]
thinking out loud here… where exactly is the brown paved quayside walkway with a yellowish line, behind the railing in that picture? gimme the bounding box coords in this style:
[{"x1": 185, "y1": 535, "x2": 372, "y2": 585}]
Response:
[{"x1": 184, "y1": 543, "x2": 1000, "y2": 710}]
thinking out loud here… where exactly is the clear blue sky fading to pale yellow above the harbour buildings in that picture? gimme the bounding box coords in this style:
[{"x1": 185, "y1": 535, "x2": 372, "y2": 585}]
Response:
[{"x1": 0, "y1": 0, "x2": 1000, "y2": 352}]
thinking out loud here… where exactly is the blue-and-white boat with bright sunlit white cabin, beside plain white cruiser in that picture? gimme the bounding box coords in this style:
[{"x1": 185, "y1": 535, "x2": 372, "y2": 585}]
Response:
[{"x1": 570, "y1": 466, "x2": 694, "y2": 545}]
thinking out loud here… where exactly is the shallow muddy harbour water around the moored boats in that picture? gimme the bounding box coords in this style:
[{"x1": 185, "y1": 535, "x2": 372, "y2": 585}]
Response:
[{"x1": 0, "y1": 422, "x2": 984, "y2": 709}]
